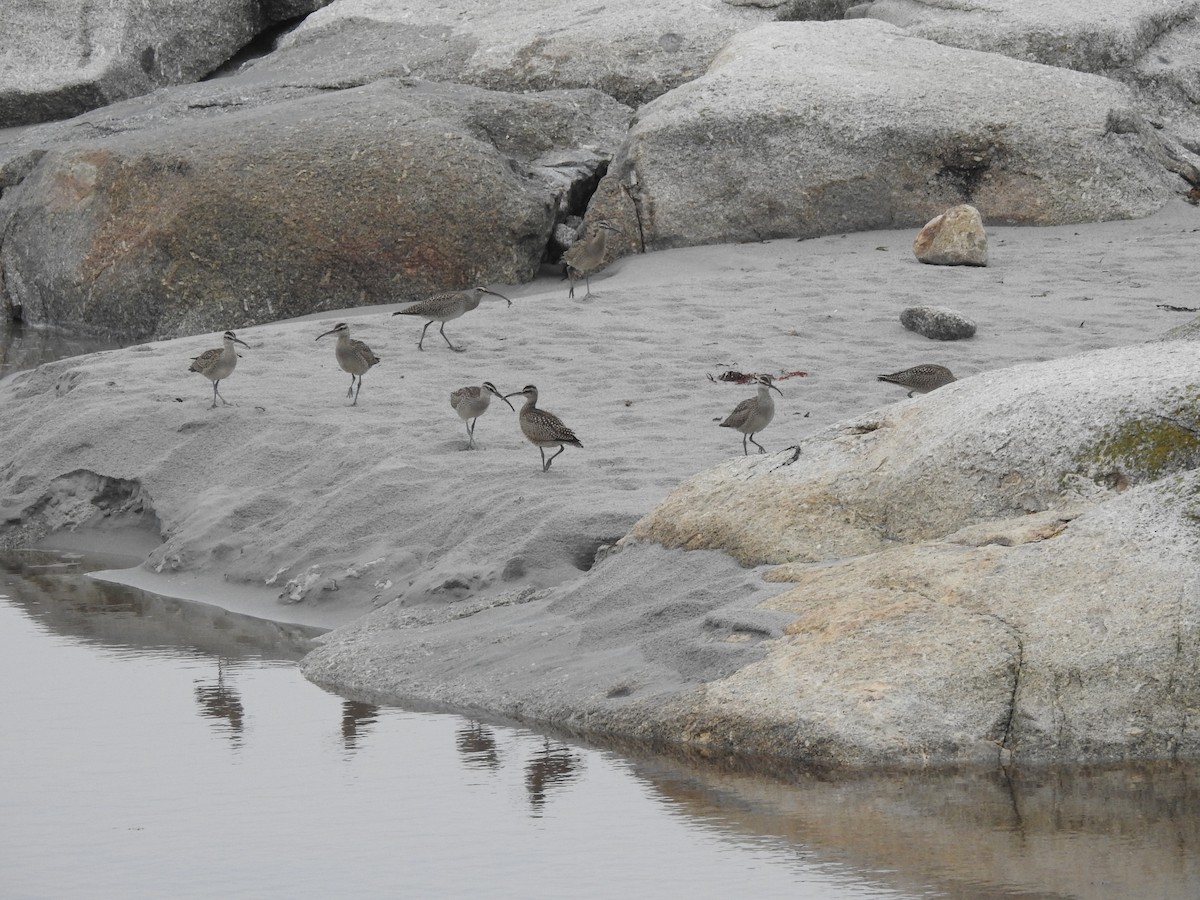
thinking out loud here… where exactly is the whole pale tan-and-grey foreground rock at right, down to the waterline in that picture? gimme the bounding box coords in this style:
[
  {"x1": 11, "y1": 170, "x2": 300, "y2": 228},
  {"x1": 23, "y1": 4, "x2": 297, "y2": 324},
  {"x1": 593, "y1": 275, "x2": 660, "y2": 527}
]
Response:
[{"x1": 626, "y1": 343, "x2": 1200, "y2": 763}]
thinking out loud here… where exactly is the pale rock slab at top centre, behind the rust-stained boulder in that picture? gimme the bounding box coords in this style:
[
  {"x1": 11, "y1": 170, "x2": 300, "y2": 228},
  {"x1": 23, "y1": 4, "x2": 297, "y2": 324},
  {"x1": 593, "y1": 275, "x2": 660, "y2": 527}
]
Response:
[{"x1": 273, "y1": 0, "x2": 770, "y2": 106}]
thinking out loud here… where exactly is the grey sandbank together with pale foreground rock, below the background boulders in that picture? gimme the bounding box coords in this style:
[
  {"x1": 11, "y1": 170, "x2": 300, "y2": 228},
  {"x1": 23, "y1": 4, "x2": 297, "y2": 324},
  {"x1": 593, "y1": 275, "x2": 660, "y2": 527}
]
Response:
[{"x1": 0, "y1": 196, "x2": 1200, "y2": 767}]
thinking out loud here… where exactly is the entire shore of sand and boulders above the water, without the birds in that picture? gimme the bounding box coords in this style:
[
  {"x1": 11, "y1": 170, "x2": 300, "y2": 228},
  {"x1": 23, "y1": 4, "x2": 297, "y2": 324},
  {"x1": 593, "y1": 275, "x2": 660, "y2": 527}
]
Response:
[{"x1": 0, "y1": 0, "x2": 1200, "y2": 767}]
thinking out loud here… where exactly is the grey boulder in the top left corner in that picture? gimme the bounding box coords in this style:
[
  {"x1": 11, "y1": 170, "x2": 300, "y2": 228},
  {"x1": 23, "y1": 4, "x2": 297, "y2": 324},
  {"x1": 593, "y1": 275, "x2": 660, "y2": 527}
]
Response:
[{"x1": 0, "y1": 0, "x2": 329, "y2": 127}]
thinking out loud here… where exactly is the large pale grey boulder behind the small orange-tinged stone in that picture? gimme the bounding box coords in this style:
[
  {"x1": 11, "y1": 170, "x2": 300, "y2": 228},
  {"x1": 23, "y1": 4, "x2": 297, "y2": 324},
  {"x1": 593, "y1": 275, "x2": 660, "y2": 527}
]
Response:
[{"x1": 614, "y1": 19, "x2": 1178, "y2": 248}]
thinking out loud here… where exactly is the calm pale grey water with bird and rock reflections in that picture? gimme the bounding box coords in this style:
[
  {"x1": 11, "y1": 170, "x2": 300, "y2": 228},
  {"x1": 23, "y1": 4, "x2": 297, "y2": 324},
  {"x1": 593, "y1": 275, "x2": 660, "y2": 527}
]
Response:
[{"x1": 0, "y1": 553, "x2": 1200, "y2": 900}]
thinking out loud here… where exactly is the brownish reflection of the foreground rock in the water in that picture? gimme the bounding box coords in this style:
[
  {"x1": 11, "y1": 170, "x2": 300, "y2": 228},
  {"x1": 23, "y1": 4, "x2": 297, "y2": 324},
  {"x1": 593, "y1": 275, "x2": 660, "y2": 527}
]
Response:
[{"x1": 623, "y1": 748, "x2": 1200, "y2": 900}]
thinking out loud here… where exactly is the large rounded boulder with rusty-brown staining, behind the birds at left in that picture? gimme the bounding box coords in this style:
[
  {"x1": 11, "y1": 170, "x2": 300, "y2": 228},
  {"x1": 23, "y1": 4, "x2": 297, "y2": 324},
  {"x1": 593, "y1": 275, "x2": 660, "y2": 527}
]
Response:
[{"x1": 0, "y1": 79, "x2": 629, "y2": 338}]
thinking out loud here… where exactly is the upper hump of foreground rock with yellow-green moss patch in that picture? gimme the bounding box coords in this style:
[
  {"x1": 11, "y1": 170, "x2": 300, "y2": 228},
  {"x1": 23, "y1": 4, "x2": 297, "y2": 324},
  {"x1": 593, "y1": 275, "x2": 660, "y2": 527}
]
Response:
[{"x1": 631, "y1": 342, "x2": 1200, "y2": 565}]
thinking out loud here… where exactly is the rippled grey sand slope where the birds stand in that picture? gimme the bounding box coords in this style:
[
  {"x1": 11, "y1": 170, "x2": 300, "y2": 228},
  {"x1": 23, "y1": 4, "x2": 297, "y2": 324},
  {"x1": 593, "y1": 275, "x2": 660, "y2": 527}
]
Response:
[{"x1": 10, "y1": 202, "x2": 1180, "y2": 625}]
